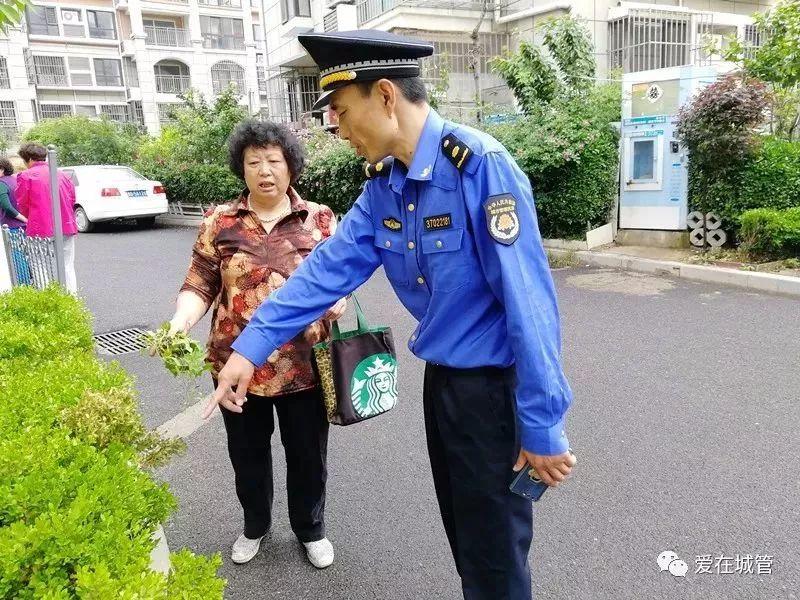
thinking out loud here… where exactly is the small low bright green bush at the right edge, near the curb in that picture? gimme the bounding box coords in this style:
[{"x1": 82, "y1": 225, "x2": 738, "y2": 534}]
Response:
[{"x1": 739, "y1": 206, "x2": 800, "y2": 257}]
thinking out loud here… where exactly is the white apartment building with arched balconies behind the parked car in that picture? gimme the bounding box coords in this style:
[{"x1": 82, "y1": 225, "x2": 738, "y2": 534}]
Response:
[{"x1": 0, "y1": 0, "x2": 265, "y2": 137}]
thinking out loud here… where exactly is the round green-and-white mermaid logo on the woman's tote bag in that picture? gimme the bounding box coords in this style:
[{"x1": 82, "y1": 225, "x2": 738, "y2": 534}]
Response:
[{"x1": 350, "y1": 354, "x2": 397, "y2": 419}]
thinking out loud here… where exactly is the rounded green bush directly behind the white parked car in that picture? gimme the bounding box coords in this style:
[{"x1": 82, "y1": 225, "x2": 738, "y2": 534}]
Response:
[{"x1": 23, "y1": 116, "x2": 142, "y2": 166}]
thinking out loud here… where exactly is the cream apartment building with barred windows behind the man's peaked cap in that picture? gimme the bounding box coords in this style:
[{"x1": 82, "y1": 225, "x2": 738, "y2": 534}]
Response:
[{"x1": 263, "y1": 0, "x2": 773, "y2": 127}]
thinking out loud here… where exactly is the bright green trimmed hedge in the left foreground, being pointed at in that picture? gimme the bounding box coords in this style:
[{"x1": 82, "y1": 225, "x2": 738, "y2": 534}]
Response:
[{"x1": 0, "y1": 287, "x2": 224, "y2": 600}]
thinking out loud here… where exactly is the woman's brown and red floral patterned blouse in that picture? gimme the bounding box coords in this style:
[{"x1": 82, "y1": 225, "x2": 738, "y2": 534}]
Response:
[{"x1": 181, "y1": 187, "x2": 336, "y2": 396}]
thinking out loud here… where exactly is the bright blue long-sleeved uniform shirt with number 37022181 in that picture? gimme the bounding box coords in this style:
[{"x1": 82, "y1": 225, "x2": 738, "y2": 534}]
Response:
[{"x1": 233, "y1": 110, "x2": 572, "y2": 455}]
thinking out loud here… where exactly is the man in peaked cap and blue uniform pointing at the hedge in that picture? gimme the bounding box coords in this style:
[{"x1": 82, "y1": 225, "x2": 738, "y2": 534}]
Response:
[{"x1": 205, "y1": 31, "x2": 575, "y2": 600}]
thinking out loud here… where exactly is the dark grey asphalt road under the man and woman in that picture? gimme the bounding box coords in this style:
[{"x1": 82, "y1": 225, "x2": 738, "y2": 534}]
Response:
[{"x1": 77, "y1": 226, "x2": 800, "y2": 600}]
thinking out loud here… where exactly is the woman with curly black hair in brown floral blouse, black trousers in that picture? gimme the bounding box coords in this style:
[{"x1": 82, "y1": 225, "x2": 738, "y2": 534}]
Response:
[{"x1": 170, "y1": 120, "x2": 344, "y2": 568}]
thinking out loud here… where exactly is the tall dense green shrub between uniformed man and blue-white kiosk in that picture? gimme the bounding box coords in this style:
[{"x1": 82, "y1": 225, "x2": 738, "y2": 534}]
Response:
[{"x1": 488, "y1": 17, "x2": 622, "y2": 238}]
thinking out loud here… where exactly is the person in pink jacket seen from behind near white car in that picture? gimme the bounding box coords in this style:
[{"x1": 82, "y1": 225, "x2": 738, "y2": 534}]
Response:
[{"x1": 16, "y1": 142, "x2": 78, "y2": 294}]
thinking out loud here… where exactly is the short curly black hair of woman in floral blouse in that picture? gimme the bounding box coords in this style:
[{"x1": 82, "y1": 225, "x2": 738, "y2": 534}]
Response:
[{"x1": 233, "y1": 119, "x2": 306, "y2": 183}]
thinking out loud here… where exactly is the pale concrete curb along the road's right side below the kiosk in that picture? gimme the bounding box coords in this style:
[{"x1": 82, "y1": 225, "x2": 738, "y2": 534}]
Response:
[{"x1": 546, "y1": 247, "x2": 800, "y2": 297}]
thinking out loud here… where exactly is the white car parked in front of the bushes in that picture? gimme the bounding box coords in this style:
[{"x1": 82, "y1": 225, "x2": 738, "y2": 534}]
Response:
[{"x1": 61, "y1": 165, "x2": 167, "y2": 233}]
